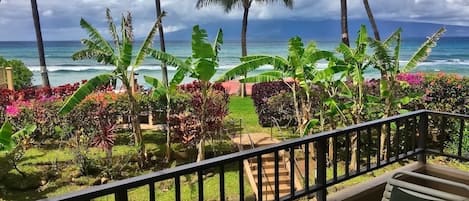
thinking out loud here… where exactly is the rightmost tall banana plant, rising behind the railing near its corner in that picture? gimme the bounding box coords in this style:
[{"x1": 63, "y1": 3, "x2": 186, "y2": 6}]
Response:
[{"x1": 369, "y1": 28, "x2": 446, "y2": 157}]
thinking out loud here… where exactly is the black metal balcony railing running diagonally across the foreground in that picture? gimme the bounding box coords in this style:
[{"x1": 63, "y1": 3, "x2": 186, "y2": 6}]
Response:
[{"x1": 42, "y1": 110, "x2": 469, "y2": 201}]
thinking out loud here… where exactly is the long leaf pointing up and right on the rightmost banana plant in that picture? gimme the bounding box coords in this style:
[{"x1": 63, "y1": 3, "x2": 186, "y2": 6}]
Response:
[{"x1": 402, "y1": 27, "x2": 446, "y2": 72}]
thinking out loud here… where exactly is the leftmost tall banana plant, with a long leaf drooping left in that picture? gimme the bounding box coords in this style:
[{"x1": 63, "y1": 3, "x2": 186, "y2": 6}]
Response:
[{"x1": 59, "y1": 9, "x2": 164, "y2": 167}]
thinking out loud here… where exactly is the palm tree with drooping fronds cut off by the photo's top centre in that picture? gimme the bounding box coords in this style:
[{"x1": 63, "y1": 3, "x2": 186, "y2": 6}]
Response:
[{"x1": 196, "y1": 0, "x2": 293, "y2": 97}]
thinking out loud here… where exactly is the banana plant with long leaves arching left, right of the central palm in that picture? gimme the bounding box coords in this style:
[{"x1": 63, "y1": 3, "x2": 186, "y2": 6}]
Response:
[{"x1": 219, "y1": 37, "x2": 334, "y2": 134}]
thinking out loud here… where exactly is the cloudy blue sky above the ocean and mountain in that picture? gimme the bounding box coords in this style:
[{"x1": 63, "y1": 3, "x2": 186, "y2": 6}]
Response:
[{"x1": 0, "y1": 0, "x2": 469, "y2": 41}]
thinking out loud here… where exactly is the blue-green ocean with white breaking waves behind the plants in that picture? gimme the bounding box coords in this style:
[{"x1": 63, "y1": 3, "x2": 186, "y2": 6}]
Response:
[{"x1": 0, "y1": 37, "x2": 469, "y2": 86}]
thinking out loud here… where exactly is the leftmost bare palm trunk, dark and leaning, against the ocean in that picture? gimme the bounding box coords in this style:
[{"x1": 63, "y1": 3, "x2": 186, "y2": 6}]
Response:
[{"x1": 31, "y1": 0, "x2": 50, "y2": 88}]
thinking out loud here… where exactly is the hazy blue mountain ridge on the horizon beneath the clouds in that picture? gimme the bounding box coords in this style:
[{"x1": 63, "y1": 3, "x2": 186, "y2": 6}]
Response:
[{"x1": 162, "y1": 20, "x2": 469, "y2": 41}]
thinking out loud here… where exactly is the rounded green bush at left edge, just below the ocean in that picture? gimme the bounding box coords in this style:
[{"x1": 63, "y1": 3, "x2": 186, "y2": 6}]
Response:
[{"x1": 0, "y1": 56, "x2": 33, "y2": 90}]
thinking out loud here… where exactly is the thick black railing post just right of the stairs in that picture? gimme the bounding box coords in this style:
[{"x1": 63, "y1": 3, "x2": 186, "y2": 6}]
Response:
[{"x1": 316, "y1": 138, "x2": 327, "y2": 201}]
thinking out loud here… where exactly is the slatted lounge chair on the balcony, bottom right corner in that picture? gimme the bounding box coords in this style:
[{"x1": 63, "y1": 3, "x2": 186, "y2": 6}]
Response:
[{"x1": 382, "y1": 171, "x2": 469, "y2": 201}]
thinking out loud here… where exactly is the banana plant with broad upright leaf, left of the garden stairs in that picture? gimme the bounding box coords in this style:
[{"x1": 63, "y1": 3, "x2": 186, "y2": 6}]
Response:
[{"x1": 148, "y1": 25, "x2": 223, "y2": 161}]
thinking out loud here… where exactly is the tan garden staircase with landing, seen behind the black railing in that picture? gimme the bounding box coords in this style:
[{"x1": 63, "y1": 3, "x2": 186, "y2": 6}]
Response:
[{"x1": 232, "y1": 134, "x2": 301, "y2": 200}]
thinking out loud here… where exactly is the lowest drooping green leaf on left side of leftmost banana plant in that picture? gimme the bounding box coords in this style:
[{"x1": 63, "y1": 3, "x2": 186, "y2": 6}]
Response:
[{"x1": 59, "y1": 74, "x2": 112, "y2": 114}]
